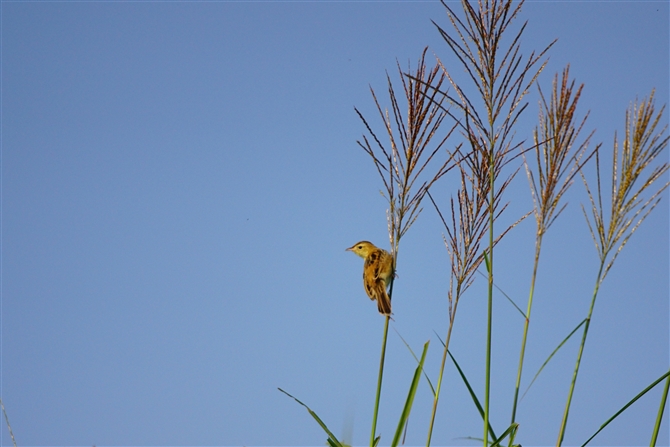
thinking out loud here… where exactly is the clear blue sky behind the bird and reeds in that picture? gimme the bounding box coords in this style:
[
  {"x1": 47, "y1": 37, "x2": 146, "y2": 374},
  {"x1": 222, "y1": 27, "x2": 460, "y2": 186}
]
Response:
[{"x1": 0, "y1": 1, "x2": 670, "y2": 446}]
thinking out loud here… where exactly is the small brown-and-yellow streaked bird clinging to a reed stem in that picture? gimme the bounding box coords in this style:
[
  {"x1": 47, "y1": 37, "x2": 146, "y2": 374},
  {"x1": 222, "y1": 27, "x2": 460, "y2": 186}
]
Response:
[{"x1": 347, "y1": 241, "x2": 395, "y2": 315}]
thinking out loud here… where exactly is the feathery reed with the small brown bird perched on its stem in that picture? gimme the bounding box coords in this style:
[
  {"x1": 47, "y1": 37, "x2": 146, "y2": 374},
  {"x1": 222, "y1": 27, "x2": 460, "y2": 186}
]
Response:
[{"x1": 356, "y1": 48, "x2": 462, "y2": 446}]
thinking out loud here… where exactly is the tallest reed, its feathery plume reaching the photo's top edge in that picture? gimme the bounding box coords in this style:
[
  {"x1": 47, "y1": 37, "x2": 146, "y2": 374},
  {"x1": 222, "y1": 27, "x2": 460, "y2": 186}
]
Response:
[{"x1": 428, "y1": 0, "x2": 553, "y2": 447}]
